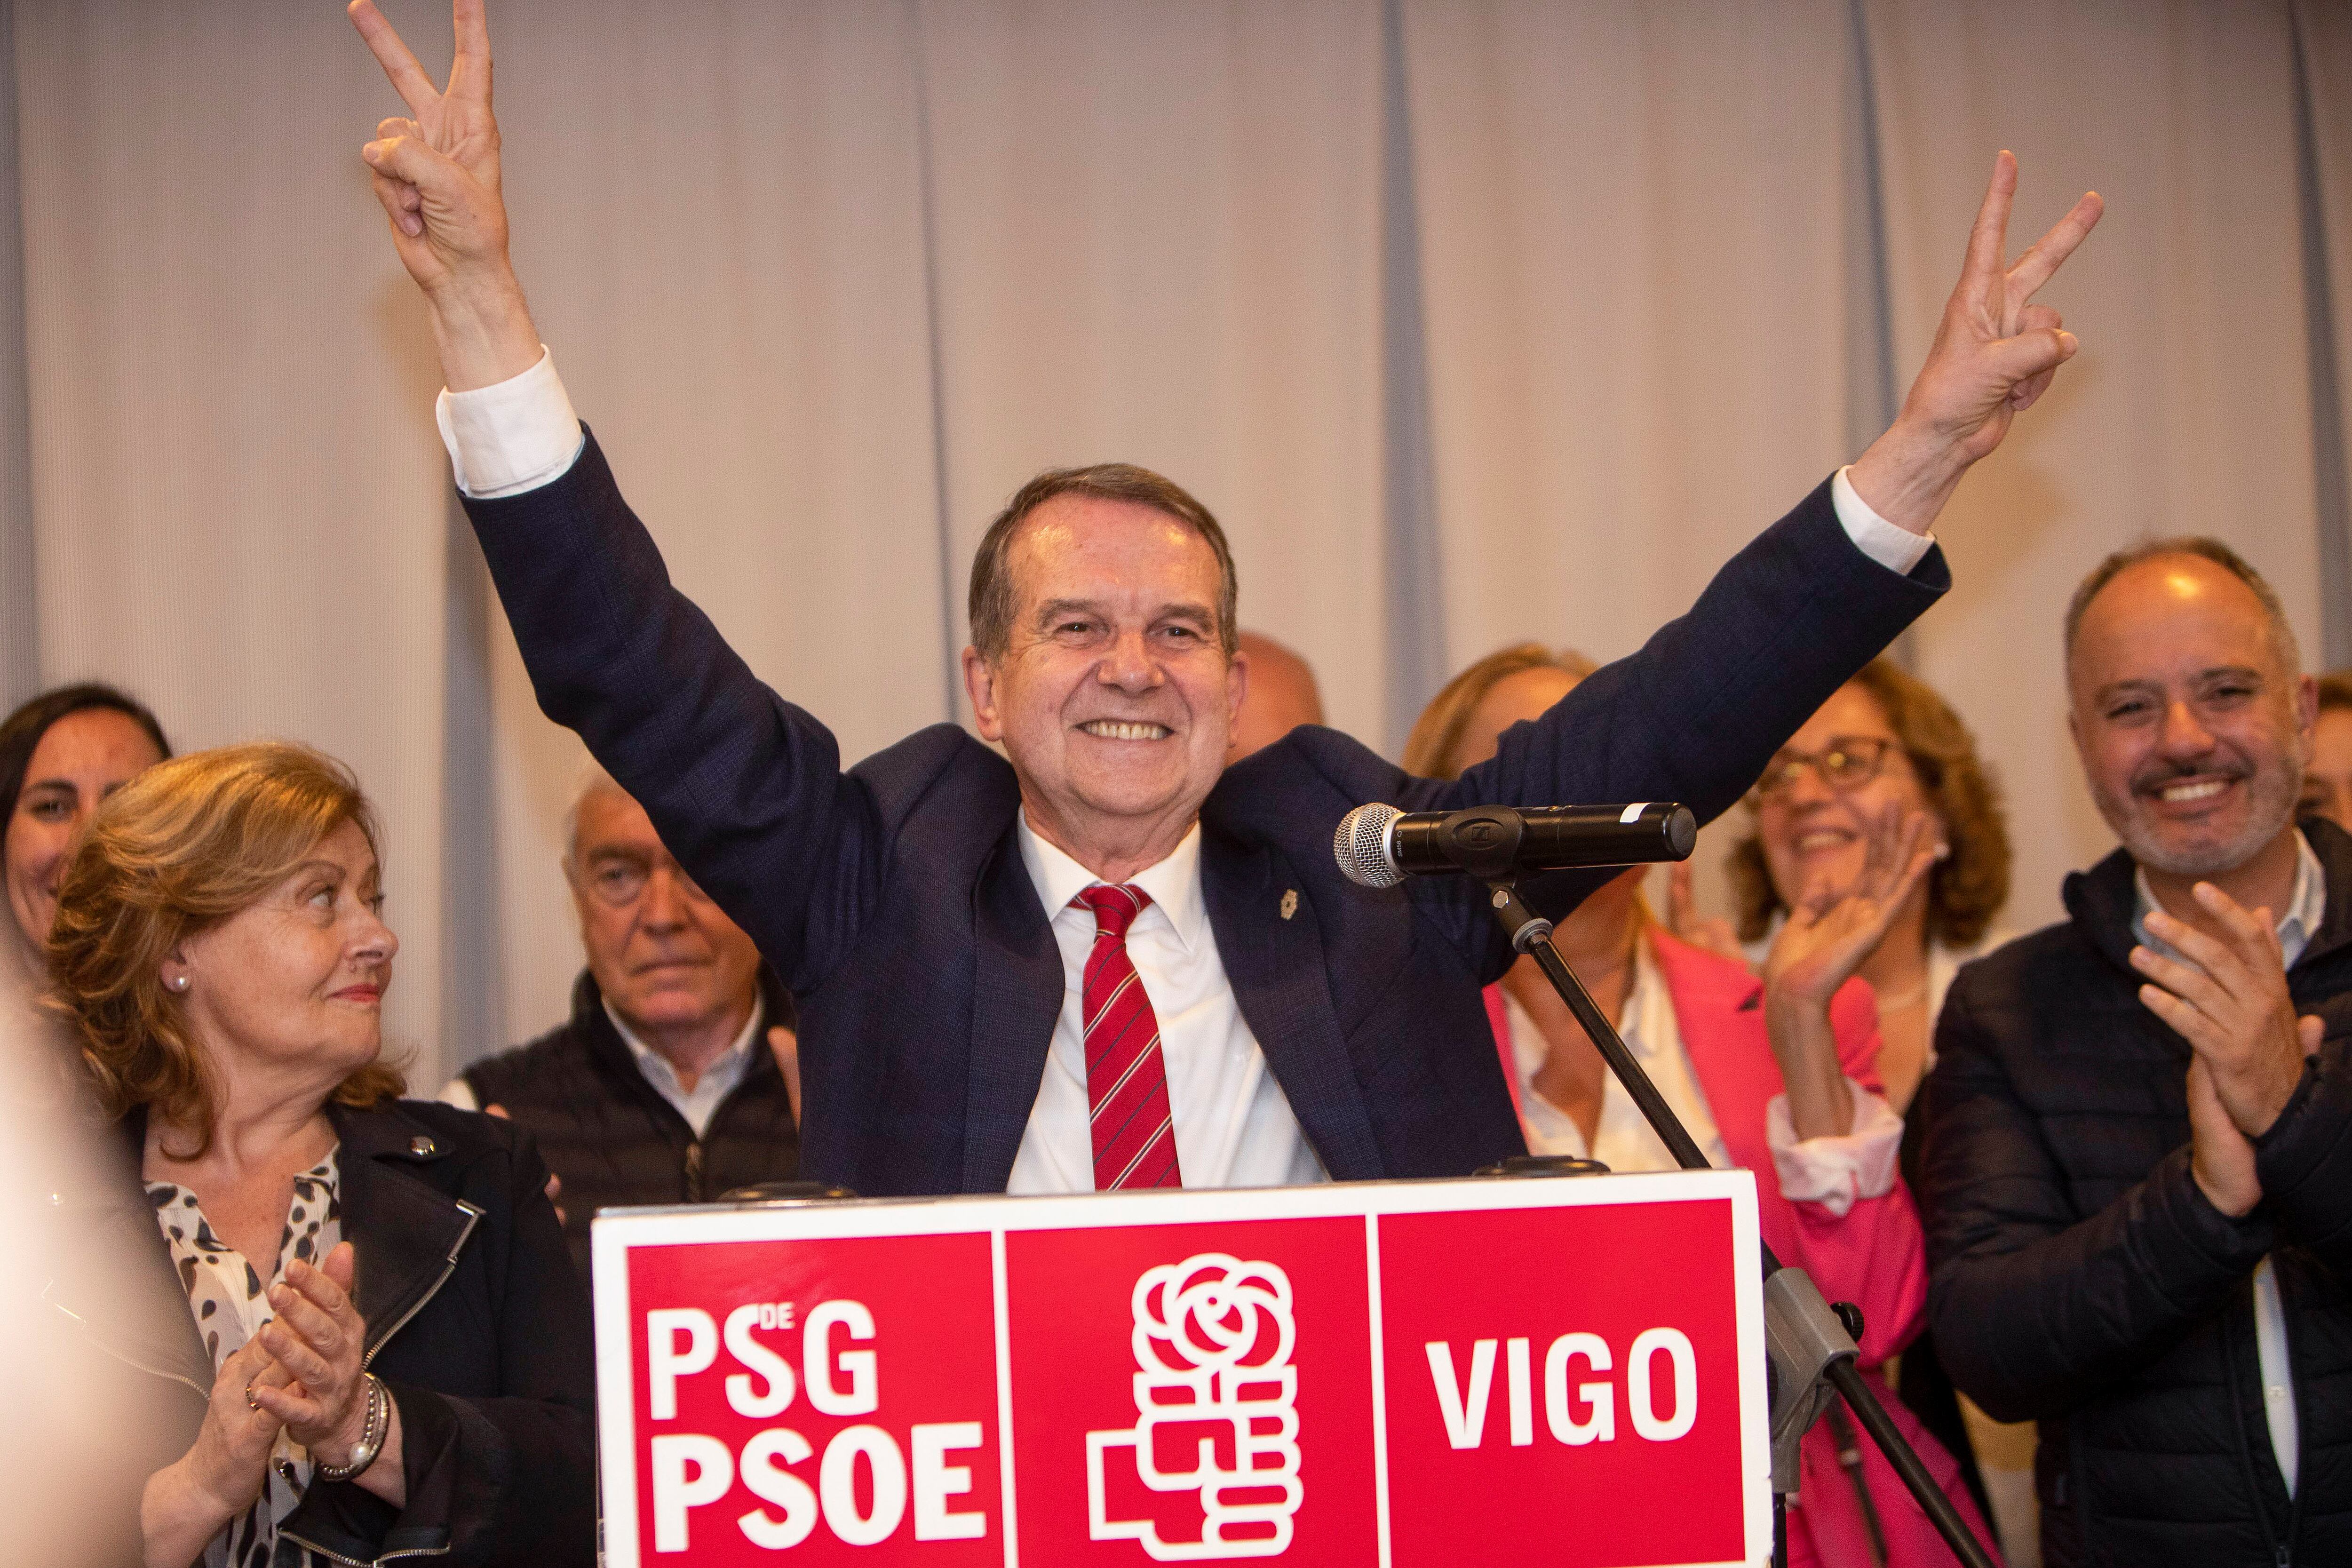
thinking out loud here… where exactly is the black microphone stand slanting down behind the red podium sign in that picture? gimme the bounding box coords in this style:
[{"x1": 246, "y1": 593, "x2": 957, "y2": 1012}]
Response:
[{"x1": 1463, "y1": 883, "x2": 1994, "y2": 1568}]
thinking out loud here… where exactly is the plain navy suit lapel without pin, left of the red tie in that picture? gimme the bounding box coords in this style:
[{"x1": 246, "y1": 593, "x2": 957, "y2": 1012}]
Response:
[{"x1": 960, "y1": 820, "x2": 1065, "y2": 1192}]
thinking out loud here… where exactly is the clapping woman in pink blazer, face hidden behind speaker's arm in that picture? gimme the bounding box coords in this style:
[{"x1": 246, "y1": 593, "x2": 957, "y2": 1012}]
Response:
[{"x1": 1404, "y1": 644, "x2": 1992, "y2": 1568}]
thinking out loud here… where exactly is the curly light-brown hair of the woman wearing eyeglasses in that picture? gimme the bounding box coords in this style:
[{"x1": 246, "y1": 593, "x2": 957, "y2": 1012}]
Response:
[{"x1": 1724, "y1": 658, "x2": 2009, "y2": 947}]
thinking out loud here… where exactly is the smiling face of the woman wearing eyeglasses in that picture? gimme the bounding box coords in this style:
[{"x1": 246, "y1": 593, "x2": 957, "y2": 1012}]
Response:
[{"x1": 1757, "y1": 682, "x2": 1950, "y2": 907}]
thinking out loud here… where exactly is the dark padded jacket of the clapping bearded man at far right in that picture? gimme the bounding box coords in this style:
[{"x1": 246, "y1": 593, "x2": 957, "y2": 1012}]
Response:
[{"x1": 1919, "y1": 818, "x2": 2352, "y2": 1568}]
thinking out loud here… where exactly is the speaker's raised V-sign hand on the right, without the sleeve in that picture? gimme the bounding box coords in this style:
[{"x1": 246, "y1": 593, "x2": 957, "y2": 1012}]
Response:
[{"x1": 1849, "y1": 153, "x2": 2105, "y2": 533}]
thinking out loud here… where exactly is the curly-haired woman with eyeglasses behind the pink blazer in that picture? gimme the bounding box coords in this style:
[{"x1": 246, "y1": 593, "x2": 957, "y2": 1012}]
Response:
[{"x1": 1675, "y1": 658, "x2": 2039, "y2": 1563}]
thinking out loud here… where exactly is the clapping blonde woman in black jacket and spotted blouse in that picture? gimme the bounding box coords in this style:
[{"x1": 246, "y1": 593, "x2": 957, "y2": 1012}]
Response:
[{"x1": 47, "y1": 745, "x2": 595, "y2": 1568}]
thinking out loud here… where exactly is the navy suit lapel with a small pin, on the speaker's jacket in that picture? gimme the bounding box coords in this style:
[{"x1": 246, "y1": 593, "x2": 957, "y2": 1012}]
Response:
[{"x1": 1200, "y1": 823, "x2": 1385, "y2": 1180}]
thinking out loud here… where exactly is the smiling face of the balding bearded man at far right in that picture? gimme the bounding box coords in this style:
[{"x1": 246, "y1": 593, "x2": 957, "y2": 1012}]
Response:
[{"x1": 2067, "y1": 555, "x2": 2314, "y2": 877}]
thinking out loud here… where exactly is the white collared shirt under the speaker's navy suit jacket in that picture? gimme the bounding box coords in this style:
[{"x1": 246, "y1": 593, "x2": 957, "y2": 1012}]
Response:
[{"x1": 1004, "y1": 811, "x2": 1329, "y2": 1192}]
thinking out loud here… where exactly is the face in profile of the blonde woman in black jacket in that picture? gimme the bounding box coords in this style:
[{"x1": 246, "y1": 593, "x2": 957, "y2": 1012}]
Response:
[{"x1": 162, "y1": 823, "x2": 400, "y2": 1086}]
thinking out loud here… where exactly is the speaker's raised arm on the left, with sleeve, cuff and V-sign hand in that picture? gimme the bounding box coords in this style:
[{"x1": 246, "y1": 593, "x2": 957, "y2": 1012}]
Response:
[{"x1": 350, "y1": 0, "x2": 877, "y2": 990}]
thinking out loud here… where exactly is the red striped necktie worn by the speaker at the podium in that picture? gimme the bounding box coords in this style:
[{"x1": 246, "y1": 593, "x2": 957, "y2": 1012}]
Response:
[{"x1": 1070, "y1": 884, "x2": 1183, "y2": 1192}]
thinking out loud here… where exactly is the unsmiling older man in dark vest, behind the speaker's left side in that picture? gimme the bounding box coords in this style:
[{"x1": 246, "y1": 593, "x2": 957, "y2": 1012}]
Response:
[{"x1": 440, "y1": 773, "x2": 800, "y2": 1276}]
